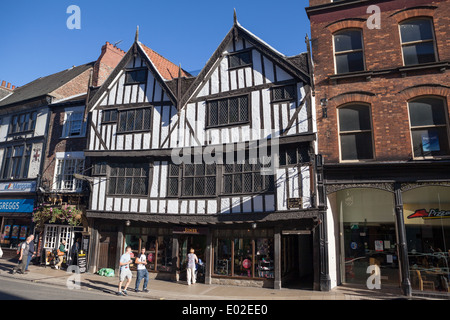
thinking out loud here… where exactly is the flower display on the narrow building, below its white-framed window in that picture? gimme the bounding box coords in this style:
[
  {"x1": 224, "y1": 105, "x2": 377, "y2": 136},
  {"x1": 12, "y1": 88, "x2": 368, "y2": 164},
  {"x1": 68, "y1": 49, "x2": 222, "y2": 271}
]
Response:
[{"x1": 32, "y1": 204, "x2": 82, "y2": 228}]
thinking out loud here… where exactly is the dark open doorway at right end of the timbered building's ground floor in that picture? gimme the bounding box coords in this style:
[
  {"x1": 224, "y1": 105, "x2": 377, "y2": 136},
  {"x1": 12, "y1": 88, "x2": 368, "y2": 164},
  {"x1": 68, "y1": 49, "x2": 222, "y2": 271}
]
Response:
[{"x1": 281, "y1": 231, "x2": 314, "y2": 289}]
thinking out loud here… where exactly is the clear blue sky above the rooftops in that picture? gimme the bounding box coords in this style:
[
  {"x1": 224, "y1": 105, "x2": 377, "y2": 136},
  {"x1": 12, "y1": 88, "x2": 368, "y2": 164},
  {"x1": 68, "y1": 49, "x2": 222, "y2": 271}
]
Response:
[{"x1": 0, "y1": 0, "x2": 310, "y2": 86}]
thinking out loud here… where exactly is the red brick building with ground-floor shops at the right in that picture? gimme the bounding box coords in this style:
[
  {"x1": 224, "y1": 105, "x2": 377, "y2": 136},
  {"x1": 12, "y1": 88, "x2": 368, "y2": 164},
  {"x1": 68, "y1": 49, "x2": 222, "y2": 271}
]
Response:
[{"x1": 306, "y1": 0, "x2": 450, "y2": 295}]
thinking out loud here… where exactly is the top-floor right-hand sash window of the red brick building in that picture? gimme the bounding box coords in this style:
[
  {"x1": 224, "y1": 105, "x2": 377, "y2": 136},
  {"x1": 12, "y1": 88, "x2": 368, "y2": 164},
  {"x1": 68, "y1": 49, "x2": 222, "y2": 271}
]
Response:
[{"x1": 400, "y1": 18, "x2": 436, "y2": 66}]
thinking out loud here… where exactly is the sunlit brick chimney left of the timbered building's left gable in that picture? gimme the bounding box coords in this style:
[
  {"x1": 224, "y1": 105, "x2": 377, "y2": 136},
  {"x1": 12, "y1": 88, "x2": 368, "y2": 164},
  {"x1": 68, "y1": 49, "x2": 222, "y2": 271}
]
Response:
[{"x1": 92, "y1": 42, "x2": 125, "y2": 87}]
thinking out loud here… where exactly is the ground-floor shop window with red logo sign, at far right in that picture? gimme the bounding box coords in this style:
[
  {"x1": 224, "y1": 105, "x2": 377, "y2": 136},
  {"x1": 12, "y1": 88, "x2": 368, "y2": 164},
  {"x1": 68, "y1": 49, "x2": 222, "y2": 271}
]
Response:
[{"x1": 402, "y1": 186, "x2": 450, "y2": 293}]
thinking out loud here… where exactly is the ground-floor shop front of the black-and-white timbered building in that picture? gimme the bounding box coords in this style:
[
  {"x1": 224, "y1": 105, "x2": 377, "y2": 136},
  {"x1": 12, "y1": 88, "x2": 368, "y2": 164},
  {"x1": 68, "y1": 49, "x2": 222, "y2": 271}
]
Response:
[{"x1": 91, "y1": 219, "x2": 314, "y2": 288}]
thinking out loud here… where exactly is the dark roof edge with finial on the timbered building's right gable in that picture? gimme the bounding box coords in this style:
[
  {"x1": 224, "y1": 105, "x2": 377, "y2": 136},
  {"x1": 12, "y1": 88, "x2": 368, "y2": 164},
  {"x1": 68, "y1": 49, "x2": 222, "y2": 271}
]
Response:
[{"x1": 179, "y1": 19, "x2": 310, "y2": 108}]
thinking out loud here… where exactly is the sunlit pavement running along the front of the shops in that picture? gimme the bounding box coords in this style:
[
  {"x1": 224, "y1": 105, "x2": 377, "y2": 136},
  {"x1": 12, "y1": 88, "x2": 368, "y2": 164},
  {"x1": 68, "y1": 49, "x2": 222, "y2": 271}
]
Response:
[{"x1": 0, "y1": 259, "x2": 444, "y2": 300}]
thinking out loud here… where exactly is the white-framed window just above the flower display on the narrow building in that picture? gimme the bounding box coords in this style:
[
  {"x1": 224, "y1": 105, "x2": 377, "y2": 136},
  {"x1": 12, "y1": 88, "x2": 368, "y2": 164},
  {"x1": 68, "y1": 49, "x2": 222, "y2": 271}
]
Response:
[{"x1": 52, "y1": 151, "x2": 85, "y2": 192}]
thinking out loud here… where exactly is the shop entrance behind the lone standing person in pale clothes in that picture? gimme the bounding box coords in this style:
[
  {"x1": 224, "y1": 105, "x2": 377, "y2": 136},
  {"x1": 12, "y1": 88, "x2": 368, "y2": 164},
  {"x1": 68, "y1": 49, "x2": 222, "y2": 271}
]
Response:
[{"x1": 178, "y1": 235, "x2": 207, "y2": 283}]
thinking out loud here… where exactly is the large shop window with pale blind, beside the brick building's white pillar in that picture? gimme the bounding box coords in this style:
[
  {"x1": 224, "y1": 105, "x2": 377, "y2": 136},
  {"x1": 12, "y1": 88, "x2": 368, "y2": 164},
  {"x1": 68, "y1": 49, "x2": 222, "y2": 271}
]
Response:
[{"x1": 336, "y1": 188, "x2": 399, "y2": 286}]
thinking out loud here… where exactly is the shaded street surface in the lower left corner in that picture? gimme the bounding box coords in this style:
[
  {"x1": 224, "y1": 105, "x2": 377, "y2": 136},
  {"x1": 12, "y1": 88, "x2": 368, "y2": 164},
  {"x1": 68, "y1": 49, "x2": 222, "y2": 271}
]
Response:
[{"x1": 0, "y1": 277, "x2": 147, "y2": 300}]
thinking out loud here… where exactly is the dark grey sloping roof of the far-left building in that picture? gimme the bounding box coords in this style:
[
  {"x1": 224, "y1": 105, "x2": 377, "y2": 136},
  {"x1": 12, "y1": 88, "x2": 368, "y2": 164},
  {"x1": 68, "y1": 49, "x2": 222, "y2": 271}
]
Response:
[{"x1": 0, "y1": 61, "x2": 95, "y2": 107}]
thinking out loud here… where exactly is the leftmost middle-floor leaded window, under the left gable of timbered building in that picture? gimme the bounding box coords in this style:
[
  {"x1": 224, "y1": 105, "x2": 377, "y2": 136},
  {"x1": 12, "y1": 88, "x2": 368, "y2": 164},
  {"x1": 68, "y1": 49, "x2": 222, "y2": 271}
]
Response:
[{"x1": 108, "y1": 163, "x2": 149, "y2": 195}]
